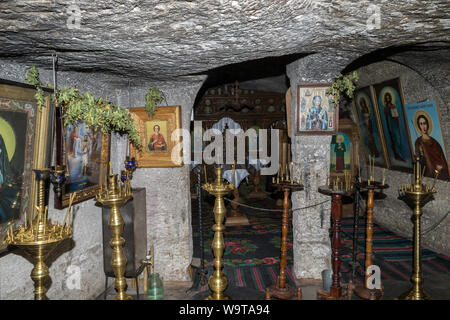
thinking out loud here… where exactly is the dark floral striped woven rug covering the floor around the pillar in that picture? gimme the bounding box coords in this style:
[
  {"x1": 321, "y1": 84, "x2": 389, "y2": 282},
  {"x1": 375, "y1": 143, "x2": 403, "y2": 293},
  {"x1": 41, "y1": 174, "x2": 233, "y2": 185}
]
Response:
[{"x1": 193, "y1": 199, "x2": 450, "y2": 291}]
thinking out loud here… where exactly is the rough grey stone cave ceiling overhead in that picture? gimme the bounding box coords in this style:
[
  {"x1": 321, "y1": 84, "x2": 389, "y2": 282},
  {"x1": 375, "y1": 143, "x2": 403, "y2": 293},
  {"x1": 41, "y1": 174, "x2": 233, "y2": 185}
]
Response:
[{"x1": 0, "y1": 0, "x2": 450, "y2": 80}]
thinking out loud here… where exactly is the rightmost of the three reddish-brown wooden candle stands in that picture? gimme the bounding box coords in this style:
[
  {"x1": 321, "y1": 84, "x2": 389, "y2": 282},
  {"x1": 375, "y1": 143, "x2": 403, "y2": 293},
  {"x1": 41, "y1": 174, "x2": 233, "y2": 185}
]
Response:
[{"x1": 355, "y1": 181, "x2": 388, "y2": 300}]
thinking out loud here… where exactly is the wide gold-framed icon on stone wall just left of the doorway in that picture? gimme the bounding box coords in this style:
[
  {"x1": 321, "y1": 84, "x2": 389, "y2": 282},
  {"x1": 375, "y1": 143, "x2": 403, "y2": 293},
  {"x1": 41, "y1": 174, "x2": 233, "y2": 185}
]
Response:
[{"x1": 130, "y1": 106, "x2": 183, "y2": 168}]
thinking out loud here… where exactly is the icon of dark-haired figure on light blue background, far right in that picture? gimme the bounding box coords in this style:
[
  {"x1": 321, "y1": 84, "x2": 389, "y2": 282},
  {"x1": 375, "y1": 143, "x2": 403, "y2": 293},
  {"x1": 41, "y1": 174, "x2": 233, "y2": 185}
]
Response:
[{"x1": 405, "y1": 101, "x2": 449, "y2": 180}]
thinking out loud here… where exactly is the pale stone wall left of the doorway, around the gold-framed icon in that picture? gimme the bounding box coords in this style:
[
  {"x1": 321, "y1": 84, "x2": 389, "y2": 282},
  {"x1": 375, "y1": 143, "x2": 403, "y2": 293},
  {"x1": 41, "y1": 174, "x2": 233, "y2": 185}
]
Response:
[{"x1": 111, "y1": 76, "x2": 205, "y2": 281}]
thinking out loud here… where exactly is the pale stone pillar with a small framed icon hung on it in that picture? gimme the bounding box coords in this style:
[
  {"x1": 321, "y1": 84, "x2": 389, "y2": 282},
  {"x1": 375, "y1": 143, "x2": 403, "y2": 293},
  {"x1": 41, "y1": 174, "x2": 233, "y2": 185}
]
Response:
[{"x1": 286, "y1": 54, "x2": 351, "y2": 280}]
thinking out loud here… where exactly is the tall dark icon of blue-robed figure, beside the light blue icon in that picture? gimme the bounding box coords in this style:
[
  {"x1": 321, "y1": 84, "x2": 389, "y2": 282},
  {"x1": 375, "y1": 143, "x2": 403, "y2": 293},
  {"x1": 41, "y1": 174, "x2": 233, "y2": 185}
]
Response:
[{"x1": 372, "y1": 78, "x2": 413, "y2": 172}]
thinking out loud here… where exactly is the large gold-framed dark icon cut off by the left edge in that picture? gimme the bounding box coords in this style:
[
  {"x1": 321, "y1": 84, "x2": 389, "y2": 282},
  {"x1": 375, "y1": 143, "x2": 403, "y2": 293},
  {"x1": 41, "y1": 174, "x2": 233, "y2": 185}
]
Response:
[{"x1": 0, "y1": 80, "x2": 53, "y2": 250}]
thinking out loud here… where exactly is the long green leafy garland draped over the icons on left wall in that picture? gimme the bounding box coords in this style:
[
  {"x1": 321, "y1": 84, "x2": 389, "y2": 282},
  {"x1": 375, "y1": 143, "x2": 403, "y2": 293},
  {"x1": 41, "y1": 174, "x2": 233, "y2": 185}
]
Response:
[{"x1": 26, "y1": 66, "x2": 142, "y2": 149}]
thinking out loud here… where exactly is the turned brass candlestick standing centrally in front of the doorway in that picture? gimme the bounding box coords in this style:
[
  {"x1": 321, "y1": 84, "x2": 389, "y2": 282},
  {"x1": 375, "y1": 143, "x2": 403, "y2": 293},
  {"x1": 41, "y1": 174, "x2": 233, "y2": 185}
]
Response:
[{"x1": 203, "y1": 166, "x2": 234, "y2": 300}]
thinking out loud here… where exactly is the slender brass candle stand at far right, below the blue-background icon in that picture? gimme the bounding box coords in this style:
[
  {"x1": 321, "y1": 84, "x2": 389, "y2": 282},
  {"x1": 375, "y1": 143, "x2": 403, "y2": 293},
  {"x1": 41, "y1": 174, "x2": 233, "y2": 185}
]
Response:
[{"x1": 397, "y1": 157, "x2": 438, "y2": 300}]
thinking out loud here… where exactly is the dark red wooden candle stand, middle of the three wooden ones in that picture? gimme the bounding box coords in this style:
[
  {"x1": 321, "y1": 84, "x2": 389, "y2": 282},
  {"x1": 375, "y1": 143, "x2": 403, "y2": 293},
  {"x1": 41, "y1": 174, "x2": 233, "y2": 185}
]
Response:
[{"x1": 317, "y1": 186, "x2": 354, "y2": 300}]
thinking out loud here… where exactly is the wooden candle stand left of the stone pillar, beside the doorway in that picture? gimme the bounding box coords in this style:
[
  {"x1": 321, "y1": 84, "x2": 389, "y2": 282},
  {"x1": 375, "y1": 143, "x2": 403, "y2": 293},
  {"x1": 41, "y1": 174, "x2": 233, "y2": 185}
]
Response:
[{"x1": 266, "y1": 183, "x2": 303, "y2": 300}]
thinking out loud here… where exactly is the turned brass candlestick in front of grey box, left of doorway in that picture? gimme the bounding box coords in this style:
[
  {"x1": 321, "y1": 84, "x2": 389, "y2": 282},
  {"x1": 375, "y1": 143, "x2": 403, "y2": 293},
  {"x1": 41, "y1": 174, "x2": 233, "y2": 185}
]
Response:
[{"x1": 95, "y1": 174, "x2": 132, "y2": 300}]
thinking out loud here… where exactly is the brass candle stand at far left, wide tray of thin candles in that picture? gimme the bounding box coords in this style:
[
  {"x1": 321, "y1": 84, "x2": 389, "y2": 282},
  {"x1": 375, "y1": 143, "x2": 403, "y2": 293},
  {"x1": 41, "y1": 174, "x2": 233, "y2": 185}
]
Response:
[{"x1": 6, "y1": 168, "x2": 75, "y2": 300}]
